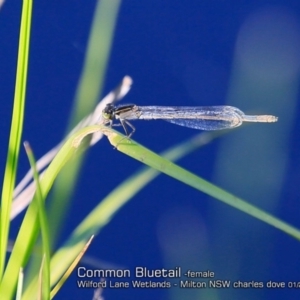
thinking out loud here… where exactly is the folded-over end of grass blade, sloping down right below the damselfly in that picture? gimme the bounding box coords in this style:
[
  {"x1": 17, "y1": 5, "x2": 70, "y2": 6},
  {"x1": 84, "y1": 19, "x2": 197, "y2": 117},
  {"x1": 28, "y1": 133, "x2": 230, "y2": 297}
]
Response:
[{"x1": 101, "y1": 126, "x2": 300, "y2": 240}]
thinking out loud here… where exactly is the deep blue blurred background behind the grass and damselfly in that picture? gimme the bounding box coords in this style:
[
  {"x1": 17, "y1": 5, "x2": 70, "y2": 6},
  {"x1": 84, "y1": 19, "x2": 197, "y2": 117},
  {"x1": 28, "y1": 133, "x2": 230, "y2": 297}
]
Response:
[{"x1": 0, "y1": 0, "x2": 300, "y2": 300}]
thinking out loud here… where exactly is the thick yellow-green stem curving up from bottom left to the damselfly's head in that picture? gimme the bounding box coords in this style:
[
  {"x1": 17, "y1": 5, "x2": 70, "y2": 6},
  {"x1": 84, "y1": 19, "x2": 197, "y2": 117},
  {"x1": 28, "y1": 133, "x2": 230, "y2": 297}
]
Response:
[{"x1": 0, "y1": 126, "x2": 100, "y2": 300}]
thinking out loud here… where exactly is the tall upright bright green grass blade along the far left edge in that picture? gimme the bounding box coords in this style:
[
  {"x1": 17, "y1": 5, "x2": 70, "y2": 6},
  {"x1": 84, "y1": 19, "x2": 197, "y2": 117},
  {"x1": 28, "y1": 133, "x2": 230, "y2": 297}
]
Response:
[{"x1": 0, "y1": 0, "x2": 32, "y2": 281}]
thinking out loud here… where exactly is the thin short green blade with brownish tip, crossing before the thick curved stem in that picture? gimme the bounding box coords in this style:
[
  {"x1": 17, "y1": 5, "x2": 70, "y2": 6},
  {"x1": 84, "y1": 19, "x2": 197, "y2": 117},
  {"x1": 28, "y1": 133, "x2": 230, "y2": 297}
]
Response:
[{"x1": 24, "y1": 142, "x2": 50, "y2": 300}]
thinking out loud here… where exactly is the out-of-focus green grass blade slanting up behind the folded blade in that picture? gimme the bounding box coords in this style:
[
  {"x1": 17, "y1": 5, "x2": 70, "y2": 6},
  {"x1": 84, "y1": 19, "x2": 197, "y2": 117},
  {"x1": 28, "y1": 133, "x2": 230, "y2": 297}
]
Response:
[{"x1": 25, "y1": 132, "x2": 220, "y2": 292}]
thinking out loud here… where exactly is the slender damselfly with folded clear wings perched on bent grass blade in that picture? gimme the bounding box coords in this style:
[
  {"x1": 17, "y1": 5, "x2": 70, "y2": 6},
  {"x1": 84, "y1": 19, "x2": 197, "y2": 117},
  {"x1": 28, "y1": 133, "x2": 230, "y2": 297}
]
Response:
[{"x1": 102, "y1": 103, "x2": 278, "y2": 138}]
